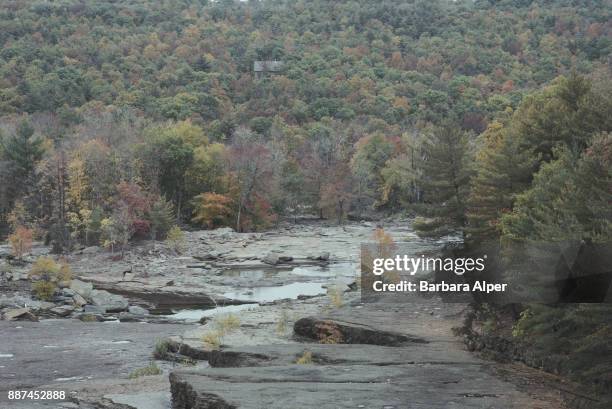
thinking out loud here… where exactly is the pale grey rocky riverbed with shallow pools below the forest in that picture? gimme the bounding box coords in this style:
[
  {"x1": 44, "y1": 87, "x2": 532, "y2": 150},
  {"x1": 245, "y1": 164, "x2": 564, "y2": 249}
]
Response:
[{"x1": 0, "y1": 221, "x2": 569, "y2": 409}]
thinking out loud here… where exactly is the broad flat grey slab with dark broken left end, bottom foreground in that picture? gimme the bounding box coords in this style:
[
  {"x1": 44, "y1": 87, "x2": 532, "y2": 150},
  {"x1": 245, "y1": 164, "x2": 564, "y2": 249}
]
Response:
[{"x1": 170, "y1": 364, "x2": 556, "y2": 409}]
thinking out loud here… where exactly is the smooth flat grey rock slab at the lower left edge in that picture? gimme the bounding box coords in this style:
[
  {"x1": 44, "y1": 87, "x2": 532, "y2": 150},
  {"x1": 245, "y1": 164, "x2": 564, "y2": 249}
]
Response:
[{"x1": 0, "y1": 319, "x2": 184, "y2": 388}]
